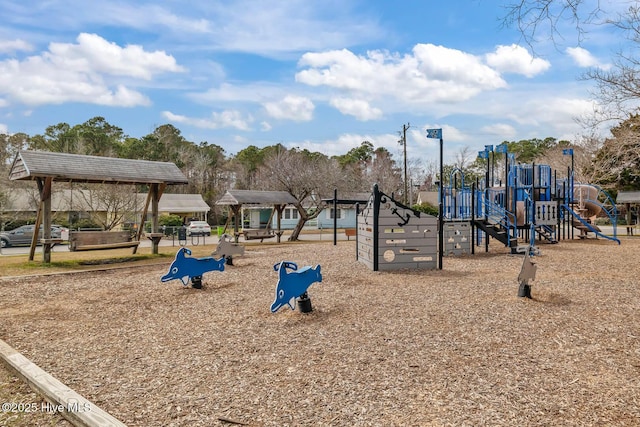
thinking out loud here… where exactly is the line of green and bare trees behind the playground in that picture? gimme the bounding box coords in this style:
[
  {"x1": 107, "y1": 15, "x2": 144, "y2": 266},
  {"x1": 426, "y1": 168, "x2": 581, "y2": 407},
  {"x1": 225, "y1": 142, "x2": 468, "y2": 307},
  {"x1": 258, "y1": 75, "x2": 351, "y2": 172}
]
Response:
[{"x1": 0, "y1": 115, "x2": 640, "y2": 240}]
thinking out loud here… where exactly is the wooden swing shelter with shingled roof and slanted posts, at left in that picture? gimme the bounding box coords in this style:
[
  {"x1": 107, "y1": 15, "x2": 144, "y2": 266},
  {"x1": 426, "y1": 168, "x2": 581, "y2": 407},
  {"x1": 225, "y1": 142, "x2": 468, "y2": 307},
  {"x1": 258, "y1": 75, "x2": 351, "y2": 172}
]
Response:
[{"x1": 9, "y1": 151, "x2": 188, "y2": 263}]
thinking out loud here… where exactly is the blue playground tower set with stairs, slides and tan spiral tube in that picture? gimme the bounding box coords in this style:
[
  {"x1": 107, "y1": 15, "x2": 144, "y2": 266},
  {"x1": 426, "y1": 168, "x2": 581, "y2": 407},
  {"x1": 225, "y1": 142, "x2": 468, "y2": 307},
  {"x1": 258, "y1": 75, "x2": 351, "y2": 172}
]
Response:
[{"x1": 440, "y1": 146, "x2": 620, "y2": 254}]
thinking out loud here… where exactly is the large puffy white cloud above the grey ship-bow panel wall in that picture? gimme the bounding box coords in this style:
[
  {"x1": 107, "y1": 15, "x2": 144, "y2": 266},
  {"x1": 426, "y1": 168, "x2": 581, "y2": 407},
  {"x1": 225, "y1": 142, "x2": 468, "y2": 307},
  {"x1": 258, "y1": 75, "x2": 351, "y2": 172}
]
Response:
[{"x1": 296, "y1": 44, "x2": 506, "y2": 109}]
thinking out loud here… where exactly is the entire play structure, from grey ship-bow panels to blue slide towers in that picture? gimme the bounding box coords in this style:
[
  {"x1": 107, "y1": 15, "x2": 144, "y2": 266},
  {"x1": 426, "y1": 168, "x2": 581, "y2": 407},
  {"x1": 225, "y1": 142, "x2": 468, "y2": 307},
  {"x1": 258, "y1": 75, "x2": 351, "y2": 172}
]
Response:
[{"x1": 356, "y1": 145, "x2": 620, "y2": 279}]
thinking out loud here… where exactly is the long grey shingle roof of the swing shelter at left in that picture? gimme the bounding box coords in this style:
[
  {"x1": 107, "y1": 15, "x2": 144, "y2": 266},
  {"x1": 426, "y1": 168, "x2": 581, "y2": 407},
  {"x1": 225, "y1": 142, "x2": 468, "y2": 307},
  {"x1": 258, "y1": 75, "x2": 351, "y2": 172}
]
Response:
[{"x1": 9, "y1": 151, "x2": 188, "y2": 185}]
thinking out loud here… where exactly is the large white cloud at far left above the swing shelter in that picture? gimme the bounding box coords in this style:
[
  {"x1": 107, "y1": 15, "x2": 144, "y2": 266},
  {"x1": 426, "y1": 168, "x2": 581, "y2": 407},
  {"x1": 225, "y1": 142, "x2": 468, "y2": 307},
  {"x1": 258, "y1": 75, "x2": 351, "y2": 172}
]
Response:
[{"x1": 0, "y1": 33, "x2": 183, "y2": 107}]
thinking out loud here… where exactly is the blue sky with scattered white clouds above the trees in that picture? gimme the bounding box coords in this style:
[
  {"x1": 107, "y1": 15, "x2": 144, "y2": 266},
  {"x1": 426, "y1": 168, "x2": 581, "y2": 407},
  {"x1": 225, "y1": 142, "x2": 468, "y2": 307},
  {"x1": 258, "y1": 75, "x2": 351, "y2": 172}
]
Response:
[{"x1": 0, "y1": 0, "x2": 620, "y2": 166}]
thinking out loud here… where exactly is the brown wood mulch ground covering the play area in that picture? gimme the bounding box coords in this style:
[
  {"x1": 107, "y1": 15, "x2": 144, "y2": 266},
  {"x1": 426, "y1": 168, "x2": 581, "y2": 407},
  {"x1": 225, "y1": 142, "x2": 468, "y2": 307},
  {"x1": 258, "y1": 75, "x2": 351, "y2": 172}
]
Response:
[{"x1": 0, "y1": 238, "x2": 640, "y2": 426}]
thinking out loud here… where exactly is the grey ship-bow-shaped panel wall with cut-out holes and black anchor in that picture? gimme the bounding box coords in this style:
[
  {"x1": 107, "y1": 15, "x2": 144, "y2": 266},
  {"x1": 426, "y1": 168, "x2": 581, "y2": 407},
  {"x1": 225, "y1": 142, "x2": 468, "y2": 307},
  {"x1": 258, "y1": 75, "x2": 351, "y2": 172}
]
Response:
[{"x1": 357, "y1": 186, "x2": 438, "y2": 271}]
